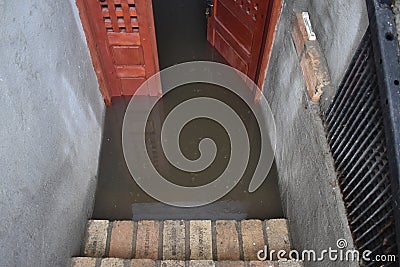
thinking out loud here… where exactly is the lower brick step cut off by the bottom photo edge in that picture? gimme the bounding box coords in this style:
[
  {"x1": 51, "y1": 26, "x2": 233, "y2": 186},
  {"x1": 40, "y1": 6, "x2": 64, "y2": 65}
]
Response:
[{"x1": 69, "y1": 257, "x2": 304, "y2": 267}]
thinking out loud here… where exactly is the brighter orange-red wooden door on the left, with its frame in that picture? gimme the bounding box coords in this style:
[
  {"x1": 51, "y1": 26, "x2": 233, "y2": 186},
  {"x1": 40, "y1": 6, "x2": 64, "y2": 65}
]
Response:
[{"x1": 77, "y1": 0, "x2": 161, "y2": 105}]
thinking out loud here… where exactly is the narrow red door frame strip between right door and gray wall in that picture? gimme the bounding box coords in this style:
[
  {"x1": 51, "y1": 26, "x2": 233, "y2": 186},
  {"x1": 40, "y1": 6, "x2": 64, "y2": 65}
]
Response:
[{"x1": 255, "y1": 0, "x2": 283, "y2": 95}]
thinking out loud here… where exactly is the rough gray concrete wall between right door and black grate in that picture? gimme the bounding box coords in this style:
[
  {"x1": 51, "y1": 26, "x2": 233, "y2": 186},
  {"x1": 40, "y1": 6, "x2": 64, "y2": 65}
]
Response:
[{"x1": 263, "y1": 0, "x2": 368, "y2": 266}]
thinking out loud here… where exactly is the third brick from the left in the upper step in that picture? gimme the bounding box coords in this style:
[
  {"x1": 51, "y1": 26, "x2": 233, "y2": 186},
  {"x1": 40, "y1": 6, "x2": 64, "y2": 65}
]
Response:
[{"x1": 135, "y1": 221, "x2": 160, "y2": 260}]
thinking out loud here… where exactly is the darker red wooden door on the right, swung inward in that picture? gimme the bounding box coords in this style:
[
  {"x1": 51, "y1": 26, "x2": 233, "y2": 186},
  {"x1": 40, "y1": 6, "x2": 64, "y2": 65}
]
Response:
[{"x1": 207, "y1": 0, "x2": 272, "y2": 82}]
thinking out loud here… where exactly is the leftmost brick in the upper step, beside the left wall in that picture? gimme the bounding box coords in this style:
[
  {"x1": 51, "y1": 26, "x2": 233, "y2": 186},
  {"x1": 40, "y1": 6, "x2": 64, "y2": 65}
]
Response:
[{"x1": 83, "y1": 220, "x2": 109, "y2": 258}]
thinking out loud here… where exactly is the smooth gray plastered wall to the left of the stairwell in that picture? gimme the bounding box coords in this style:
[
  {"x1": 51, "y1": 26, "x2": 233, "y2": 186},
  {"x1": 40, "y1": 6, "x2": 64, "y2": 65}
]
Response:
[{"x1": 0, "y1": 0, "x2": 104, "y2": 267}]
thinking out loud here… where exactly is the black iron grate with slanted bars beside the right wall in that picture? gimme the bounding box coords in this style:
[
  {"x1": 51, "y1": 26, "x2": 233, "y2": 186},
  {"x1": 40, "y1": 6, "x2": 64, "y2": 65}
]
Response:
[{"x1": 325, "y1": 30, "x2": 397, "y2": 266}]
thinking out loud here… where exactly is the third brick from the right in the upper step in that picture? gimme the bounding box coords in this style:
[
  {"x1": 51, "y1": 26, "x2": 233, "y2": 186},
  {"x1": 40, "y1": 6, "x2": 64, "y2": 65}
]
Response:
[{"x1": 216, "y1": 220, "x2": 240, "y2": 261}]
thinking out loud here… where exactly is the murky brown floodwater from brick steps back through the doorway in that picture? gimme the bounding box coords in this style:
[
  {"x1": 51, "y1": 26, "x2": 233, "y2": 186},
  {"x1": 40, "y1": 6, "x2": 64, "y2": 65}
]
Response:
[{"x1": 93, "y1": 0, "x2": 283, "y2": 220}]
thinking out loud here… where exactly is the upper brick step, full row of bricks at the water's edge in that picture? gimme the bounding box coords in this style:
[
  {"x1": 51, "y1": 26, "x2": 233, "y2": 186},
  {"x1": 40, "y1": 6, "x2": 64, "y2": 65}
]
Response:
[{"x1": 82, "y1": 219, "x2": 291, "y2": 261}]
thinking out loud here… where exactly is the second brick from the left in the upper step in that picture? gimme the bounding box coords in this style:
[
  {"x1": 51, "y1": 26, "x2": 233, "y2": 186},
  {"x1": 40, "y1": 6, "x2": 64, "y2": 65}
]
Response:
[{"x1": 109, "y1": 221, "x2": 134, "y2": 259}]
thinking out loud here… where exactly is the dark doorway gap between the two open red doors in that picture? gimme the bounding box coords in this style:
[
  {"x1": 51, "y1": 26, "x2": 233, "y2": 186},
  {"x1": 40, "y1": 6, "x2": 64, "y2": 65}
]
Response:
[{"x1": 152, "y1": 0, "x2": 227, "y2": 70}]
